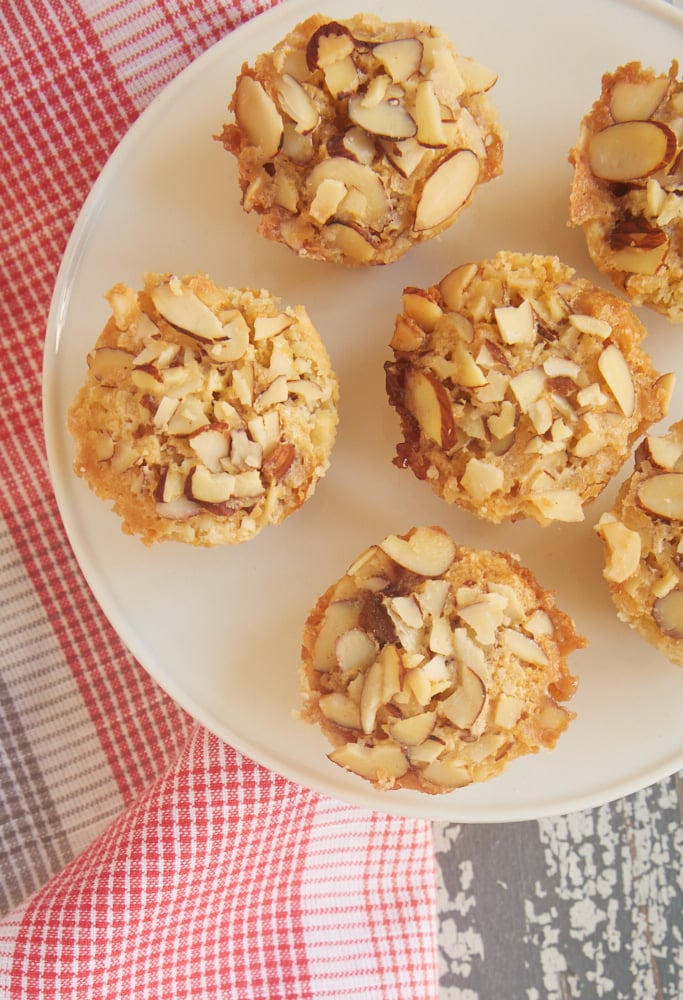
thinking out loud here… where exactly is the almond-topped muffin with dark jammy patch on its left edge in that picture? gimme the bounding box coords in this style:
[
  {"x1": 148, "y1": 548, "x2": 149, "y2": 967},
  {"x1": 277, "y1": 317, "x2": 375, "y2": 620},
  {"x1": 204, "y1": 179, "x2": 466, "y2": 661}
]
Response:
[{"x1": 386, "y1": 252, "x2": 671, "y2": 524}]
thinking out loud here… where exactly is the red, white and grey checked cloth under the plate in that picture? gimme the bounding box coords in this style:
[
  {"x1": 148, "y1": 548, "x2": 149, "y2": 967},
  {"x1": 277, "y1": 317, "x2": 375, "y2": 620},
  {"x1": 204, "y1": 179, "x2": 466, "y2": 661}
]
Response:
[{"x1": 0, "y1": 0, "x2": 438, "y2": 1000}]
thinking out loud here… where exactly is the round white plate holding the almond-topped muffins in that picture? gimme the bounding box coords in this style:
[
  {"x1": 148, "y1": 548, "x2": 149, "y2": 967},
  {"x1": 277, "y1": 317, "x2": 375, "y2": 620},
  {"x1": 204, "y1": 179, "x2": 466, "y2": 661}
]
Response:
[{"x1": 44, "y1": 0, "x2": 683, "y2": 822}]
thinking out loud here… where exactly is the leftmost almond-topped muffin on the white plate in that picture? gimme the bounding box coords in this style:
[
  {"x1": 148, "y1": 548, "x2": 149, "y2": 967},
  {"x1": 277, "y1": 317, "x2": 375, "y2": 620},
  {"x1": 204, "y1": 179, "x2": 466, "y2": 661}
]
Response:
[{"x1": 68, "y1": 275, "x2": 338, "y2": 546}]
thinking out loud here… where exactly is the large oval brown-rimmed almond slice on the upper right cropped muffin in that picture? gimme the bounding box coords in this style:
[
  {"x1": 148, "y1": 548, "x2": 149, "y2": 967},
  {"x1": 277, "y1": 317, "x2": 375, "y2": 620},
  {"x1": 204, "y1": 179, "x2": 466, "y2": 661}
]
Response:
[{"x1": 588, "y1": 121, "x2": 677, "y2": 182}]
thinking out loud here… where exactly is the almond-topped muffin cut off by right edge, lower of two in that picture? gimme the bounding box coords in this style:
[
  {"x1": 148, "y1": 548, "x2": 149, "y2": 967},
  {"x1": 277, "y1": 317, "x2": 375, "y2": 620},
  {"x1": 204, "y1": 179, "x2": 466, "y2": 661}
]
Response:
[{"x1": 595, "y1": 420, "x2": 683, "y2": 666}]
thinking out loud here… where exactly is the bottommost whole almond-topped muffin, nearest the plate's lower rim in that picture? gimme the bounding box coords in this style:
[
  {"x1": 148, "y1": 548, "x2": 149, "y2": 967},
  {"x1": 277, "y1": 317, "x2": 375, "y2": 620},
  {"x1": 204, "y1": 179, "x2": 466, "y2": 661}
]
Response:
[{"x1": 301, "y1": 527, "x2": 586, "y2": 794}]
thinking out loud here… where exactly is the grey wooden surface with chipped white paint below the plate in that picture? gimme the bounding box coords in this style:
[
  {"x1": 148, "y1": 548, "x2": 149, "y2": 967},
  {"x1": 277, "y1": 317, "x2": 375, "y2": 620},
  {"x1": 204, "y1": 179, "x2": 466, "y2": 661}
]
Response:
[{"x1": 434, "y1": 772, "x2": 683, "y2": 1000}]
